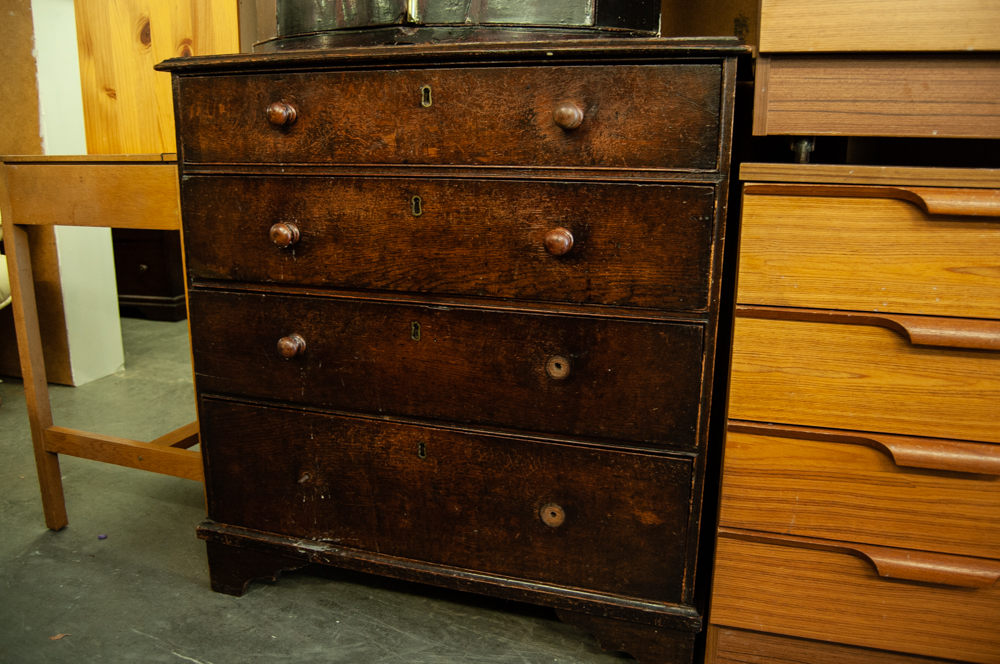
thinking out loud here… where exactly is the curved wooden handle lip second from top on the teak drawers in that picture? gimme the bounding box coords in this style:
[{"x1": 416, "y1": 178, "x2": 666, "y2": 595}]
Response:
[{"x1": 736, "y1": 304, "x2": 1000, "y2": 351}]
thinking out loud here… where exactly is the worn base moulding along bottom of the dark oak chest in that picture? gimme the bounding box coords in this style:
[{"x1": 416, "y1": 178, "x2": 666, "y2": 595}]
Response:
[{"x1": 198, "y1": 520, "x2": 702, "y2": 632}]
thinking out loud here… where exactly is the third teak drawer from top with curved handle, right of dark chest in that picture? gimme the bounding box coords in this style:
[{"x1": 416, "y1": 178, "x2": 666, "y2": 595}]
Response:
[{"x1": 719, "y1": 422, "x2": 1000, "y2": 558}]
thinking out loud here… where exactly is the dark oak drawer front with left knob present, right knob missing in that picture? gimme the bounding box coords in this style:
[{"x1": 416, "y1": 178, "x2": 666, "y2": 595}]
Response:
[{"x1": 190, "y1": 291, "x2": 704, "y2": 448}]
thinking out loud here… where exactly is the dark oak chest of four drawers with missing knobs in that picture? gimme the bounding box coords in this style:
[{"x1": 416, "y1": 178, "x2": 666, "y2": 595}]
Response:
[{"x1": 162, "y1": 39, "x2": 741, "y2": 662}]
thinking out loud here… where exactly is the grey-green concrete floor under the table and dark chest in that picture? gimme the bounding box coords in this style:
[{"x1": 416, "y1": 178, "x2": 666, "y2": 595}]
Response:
[{"x1": 0, "y1": 319, "x2": 634, "y2": 664}]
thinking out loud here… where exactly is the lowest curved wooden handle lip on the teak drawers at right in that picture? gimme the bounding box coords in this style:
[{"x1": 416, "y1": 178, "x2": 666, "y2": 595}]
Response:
[{"x1": 719, "y1": 527, "x2": 1000, "y2": 589}]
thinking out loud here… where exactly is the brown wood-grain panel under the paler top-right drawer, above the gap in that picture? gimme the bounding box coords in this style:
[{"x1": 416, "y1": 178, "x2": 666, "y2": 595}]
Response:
[{"x1": 753, "y1": 56, "x2": 1000, "y2": 138}]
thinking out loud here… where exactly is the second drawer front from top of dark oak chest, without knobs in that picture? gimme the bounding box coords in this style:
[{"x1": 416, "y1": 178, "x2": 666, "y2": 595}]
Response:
[{"x1": 183, "y1": 177, "x2": 715, "y2": 311}]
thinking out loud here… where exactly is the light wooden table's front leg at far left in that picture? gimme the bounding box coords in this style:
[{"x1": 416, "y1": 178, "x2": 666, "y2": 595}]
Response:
[{"x1": 0, "y1": 165, "x2": 69, "y2": 530}]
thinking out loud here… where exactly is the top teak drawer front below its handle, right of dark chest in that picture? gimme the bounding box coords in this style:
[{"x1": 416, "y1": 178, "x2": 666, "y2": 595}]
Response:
[{"x1": 738, "y1": 188, "x2": 1000, "y2": 318}]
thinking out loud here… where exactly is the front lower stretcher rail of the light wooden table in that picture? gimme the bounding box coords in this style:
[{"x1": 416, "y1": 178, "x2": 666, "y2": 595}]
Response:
[{"x1": 44, "y1": 426, "x2": 205, "y2": 482}]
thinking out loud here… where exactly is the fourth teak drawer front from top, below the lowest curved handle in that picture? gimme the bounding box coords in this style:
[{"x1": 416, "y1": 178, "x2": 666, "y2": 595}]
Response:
[{"x1": 712, "y1": 536, "x2": 1000, "y2": 664}]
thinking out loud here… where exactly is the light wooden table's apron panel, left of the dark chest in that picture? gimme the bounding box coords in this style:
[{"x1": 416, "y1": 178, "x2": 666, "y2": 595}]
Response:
[{"x1": 6, "y1": 162, "x2": 180, "y2": 230}]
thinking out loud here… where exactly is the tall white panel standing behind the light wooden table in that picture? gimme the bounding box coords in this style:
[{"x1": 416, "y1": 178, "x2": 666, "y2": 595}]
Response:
[{"x1": 31, "y1": 0, "x2": 125, "y2": 385}]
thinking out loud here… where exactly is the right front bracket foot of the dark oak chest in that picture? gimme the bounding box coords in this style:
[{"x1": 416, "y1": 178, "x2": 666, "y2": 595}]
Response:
[{"x1": 556, "y1": 609, "x2": 695, "y2": 664}]
